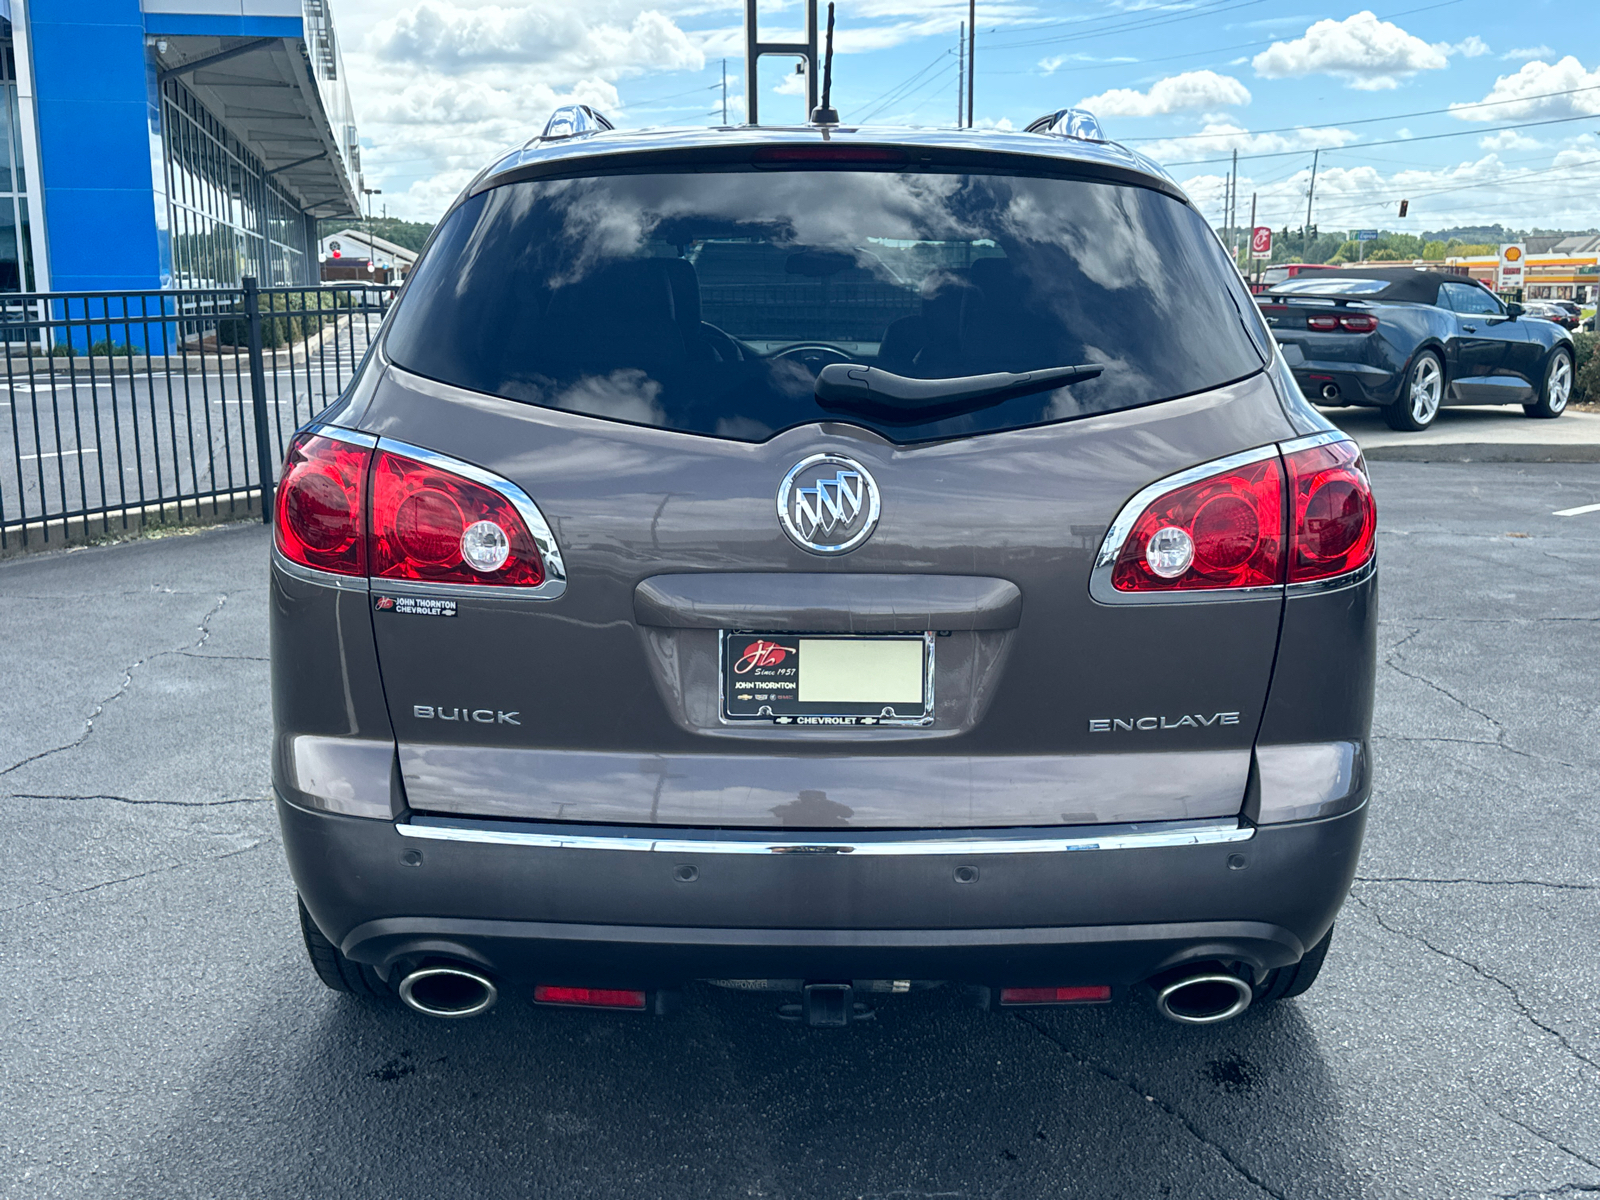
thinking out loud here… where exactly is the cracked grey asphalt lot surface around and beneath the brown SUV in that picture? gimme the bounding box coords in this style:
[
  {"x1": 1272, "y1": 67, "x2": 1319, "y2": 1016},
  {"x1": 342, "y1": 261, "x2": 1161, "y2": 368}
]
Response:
[{"x1": 0, "y1": 462, "x2": 1600, "y2": 1200}]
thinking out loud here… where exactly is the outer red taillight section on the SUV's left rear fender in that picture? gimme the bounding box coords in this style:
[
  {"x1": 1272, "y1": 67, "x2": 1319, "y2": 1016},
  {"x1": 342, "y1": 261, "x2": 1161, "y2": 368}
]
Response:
[{"x1": 272, "y1": 434, "x2": 373, "y2": 574}]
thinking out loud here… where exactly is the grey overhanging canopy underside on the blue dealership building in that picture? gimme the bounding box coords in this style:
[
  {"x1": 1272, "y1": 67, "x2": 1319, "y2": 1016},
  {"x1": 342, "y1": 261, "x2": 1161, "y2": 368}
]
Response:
[{"x1": 157, "y1": 37, "x2": 360, "y2": 218}]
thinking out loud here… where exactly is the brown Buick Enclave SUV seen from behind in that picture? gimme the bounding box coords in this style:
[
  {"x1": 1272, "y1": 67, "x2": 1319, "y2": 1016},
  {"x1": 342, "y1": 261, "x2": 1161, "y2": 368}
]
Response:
[{"x1": 269, "y1": 103, "x2": 1376, "y2": 1026}]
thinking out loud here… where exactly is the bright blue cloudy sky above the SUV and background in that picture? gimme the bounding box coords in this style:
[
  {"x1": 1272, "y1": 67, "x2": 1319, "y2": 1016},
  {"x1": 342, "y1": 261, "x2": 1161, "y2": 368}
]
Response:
[{"x1": 336, "y1": 0, "x2": 1600, "y2": 232}]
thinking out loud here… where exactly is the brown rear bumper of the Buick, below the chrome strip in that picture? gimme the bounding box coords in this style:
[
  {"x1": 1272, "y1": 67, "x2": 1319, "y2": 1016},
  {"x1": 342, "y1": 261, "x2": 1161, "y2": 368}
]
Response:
[{"x1": 278, "y1": 797, "x2": 1366, "y2": 987}]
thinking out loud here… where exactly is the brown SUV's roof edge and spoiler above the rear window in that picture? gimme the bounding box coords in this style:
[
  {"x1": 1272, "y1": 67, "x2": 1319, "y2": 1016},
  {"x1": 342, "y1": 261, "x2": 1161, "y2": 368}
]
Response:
[{"x1": 467, "y1": 125, "x2": 1187, "y2": 200}]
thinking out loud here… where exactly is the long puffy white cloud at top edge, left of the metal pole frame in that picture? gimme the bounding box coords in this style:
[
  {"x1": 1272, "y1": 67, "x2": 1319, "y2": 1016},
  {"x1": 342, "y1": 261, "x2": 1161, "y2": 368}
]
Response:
[{"x1": 374, "y1": 0, "x2": 706, "y2": 78}]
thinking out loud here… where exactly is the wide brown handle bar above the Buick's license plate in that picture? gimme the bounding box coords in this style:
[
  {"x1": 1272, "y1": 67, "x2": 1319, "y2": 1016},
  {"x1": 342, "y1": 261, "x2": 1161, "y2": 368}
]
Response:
[{"x1": 634, "y1": 571, "x2": 1022, "y2": 634}]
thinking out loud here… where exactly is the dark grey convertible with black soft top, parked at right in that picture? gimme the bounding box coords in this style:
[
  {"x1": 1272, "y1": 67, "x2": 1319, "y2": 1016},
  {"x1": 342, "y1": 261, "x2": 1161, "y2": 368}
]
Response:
[{"x1": 1256, "y1": 267, "x2": 1574, "y2": 430}]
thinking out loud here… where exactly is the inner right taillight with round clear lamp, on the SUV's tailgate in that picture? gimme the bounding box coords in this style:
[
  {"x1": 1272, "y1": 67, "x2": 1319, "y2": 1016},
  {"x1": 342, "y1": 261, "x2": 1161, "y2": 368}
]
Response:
[{"x1": 1112, "y1": 456, "x2": 1283, "y2": 592}]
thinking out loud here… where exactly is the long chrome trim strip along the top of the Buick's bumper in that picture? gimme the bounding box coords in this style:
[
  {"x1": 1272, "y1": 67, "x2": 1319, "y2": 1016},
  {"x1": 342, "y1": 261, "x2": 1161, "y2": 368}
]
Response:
[{"x1": 395, "y1": 818, "x2": 1256, "y2": 858}]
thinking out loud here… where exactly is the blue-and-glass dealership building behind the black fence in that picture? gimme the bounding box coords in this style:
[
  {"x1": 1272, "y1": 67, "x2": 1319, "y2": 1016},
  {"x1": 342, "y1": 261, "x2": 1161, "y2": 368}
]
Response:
[{"x1": 0, "y1": 0, "x2": 362, "y2": 293}]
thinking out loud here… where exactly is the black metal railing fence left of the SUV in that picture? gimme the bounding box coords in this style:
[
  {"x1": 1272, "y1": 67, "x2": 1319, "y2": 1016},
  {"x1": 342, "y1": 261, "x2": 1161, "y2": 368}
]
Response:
[{"x1": 0, "y1": 278, "x2": 397, "y2": 552}]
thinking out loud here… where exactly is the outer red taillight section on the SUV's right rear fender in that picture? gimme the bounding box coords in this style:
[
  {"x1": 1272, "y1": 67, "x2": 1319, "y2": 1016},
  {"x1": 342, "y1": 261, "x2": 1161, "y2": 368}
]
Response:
[{"x1": 1283, "y1": 442, "x2": 1378, "y2": 584}]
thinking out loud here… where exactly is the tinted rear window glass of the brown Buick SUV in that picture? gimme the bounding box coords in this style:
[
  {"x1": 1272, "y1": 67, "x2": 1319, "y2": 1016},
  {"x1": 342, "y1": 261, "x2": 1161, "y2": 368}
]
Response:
[{"x1": 386, "y1": 171, "x2": 1264, "y2": 442}]
